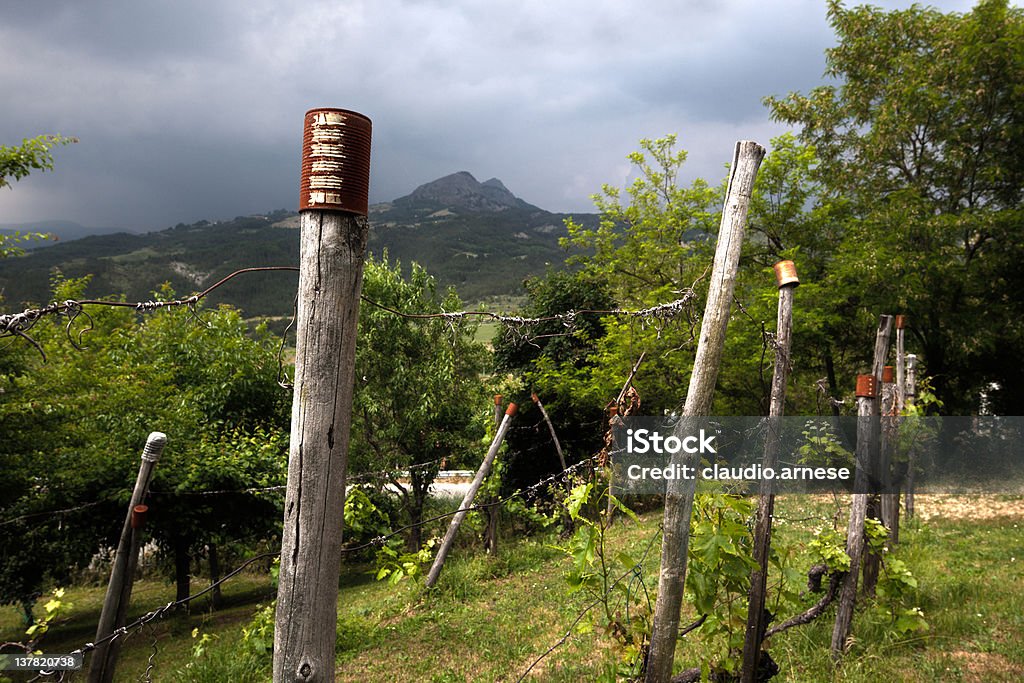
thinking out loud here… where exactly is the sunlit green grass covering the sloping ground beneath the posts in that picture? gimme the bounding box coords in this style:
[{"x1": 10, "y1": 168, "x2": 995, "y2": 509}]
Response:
[{"x1": 0, "y1": 497, "x2": 1024, "y2": 683}]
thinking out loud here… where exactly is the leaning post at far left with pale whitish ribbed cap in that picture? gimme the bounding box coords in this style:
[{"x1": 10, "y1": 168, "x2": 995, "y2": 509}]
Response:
[{"x1": 88, "y1": 432, "x2": 167, "y2": 683}]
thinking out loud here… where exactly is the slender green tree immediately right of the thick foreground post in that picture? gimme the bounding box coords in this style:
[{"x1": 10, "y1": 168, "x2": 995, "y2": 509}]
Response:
[{"x1": 349, "y1": 254, "x2": 487, "y2": 550}]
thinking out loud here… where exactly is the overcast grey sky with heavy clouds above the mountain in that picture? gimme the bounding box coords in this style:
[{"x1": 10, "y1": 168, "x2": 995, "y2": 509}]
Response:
[{"x1": 0, "y1": 0, "x2": 987, "y2": 229}]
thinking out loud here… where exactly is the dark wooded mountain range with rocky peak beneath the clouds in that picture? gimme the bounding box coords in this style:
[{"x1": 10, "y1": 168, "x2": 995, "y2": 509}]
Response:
[{"x1": 0, "y1": 172, "x2": 597, "y2": 316}]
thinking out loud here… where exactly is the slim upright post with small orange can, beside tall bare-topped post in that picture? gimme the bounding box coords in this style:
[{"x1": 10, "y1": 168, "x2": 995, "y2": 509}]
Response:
[{"x1": 740, "y1": 261, "x2": 800, "y2": 683}]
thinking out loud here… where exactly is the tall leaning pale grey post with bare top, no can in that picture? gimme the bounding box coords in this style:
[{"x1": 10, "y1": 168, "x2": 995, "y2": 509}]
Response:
[{"x1": 646, "y1": 140, "x2": 765, "y2": 683}]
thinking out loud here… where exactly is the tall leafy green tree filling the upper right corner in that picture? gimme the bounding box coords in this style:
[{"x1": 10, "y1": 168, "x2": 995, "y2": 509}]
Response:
[{"x1": 766, "y1": 0, "x2": 1024, "y2": 414}]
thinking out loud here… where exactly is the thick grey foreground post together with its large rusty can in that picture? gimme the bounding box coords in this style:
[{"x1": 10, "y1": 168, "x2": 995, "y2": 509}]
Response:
[{"x1": 273, "y1": 109, "x2": 371, "y2": 683}]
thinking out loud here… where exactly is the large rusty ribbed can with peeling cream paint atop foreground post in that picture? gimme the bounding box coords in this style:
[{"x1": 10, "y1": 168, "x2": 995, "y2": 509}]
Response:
[{"x1": 299, "y1": 108, "x2": 372, "y2": 216}]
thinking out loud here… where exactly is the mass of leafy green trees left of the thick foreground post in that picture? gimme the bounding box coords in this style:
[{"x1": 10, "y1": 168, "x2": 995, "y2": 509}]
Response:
[{"x1": 0, "y1": 281, "x2": 288, "y2": 603}]
